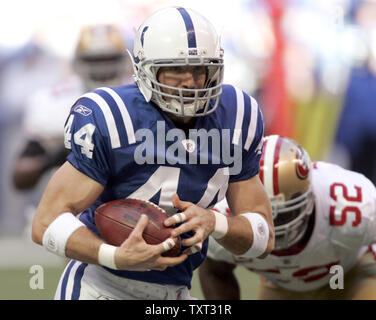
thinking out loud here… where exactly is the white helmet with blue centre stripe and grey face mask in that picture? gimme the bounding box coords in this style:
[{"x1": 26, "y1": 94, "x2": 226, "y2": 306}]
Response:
[{"x1": 130, "y1": 7, "x2": 223, "y2": 117}]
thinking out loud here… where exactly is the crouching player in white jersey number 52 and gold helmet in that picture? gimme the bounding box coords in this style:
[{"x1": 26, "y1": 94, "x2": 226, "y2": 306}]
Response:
[{"x1": 200, "y1": 135, "x2": 376, "y2": 299}]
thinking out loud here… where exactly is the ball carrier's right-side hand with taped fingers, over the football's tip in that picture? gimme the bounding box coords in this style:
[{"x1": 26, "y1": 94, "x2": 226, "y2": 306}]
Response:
[{"x1": 164, "y1": 194, "x2": 215, "y2": 253}]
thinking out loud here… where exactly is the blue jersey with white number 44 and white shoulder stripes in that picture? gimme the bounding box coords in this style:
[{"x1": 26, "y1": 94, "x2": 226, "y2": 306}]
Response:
[{"x1": 65, "y1": 85, "x2": 264, "y2": 288}]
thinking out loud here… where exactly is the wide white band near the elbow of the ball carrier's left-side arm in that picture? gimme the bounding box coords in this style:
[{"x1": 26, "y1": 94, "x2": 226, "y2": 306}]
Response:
[{"x1": 42, "y1": 212, "x2": 85, "y2": 257}]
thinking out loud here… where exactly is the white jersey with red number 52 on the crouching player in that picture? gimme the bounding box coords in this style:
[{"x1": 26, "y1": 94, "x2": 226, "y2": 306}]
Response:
[{"x1": 208, "y1": 162, "x2": 376, "y2": 291}]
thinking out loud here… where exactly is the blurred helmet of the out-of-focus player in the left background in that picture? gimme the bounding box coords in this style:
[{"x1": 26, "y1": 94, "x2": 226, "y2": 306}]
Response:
[{"x1": 73, "y1": 24, "x2": 128, "y2": 90}]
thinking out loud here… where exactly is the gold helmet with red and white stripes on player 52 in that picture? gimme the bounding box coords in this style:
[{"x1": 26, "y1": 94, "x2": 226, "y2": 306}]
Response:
[{"x1": 259, "y1": 135, "x2": 314, "y2": 250}]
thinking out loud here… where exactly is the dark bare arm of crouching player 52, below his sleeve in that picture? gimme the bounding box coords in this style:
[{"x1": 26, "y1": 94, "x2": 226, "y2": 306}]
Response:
[{"x1": 198, "y1": 258, "x2": 240, "y2": 300}]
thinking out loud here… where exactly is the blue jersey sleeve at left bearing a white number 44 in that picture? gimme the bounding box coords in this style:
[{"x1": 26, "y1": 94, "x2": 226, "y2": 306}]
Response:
[{"x1": 64, "y1": 97, "x2": 111, "y2": 185}]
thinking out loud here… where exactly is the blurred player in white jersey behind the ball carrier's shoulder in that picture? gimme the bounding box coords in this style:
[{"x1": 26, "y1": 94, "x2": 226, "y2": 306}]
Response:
[{"x1": 13, "y1": 24, "x2": 130, "y2": 191}]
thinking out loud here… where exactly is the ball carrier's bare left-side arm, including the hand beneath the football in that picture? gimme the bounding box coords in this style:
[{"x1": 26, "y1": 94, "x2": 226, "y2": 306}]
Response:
[{"x1": 32, "y1": 162, "x2": 186, "y2": 270}]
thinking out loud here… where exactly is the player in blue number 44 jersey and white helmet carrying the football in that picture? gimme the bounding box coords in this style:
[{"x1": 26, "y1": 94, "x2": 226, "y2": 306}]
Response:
[{"x1": 32, "y1": 7, "x2": 274, "y2": 299}]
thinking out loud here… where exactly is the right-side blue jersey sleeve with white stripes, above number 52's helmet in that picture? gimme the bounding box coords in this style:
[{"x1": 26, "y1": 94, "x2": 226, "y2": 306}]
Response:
[{"x1": 229, "y1": 93, "x2": 264, "y2": 182}]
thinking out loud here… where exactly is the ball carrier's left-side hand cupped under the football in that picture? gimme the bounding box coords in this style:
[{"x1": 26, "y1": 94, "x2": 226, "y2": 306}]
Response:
[{"x1": 115, "y1": 214, "x2": 187, "y2": 271}]
